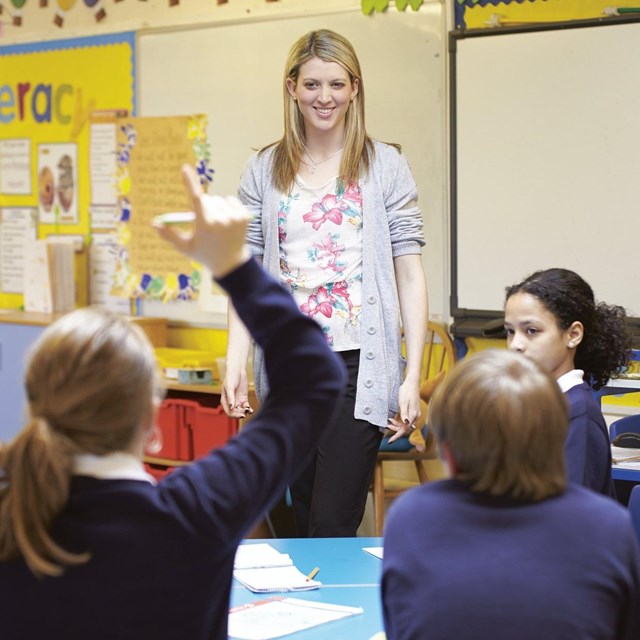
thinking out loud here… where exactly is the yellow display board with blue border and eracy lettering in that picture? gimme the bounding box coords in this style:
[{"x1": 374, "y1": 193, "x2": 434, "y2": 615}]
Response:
[{"x1": 0, "y1": 32, "x2": 136, "y2": 308}]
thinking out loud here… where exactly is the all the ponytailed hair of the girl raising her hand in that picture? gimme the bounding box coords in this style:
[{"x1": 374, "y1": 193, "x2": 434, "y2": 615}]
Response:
[{"x1": 0, "y1": 308, "x2": 159, "y2": 576}]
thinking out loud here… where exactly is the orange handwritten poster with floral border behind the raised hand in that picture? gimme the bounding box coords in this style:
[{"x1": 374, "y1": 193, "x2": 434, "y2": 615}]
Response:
[{"x1": 112, "y1": 115, "x2": 213, "y2": 302}]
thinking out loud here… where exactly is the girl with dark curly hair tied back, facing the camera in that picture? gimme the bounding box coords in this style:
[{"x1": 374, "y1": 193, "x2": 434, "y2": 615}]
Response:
[{"x1": 505, "y1": 268, "x2": 631, "y2": 496}]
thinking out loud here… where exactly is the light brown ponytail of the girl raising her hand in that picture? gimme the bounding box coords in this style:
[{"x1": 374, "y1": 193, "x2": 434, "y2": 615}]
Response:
[{"x1": 0, "y1": 417, "x2": 89, "y2": 577}]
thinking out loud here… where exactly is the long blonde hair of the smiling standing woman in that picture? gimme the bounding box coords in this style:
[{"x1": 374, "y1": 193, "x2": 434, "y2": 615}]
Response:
[{"x1": 262, "y1": 29, "x2": 374, "y2": 192}]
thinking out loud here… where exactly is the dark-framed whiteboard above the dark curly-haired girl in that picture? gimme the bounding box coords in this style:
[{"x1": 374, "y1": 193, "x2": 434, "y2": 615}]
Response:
[{"x1": 450, "y1": 22, "x2": 640, "y2": 324}]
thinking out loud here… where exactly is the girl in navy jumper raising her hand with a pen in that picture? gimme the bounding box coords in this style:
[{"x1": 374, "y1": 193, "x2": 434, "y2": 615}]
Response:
[{"x1": 0, "y1": 167, "x2": 345, "y2": 640}]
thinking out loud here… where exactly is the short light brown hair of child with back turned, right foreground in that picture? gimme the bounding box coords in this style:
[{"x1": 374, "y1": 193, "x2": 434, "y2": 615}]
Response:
[{"x1": 429, "y1": 349, "x2": 569, "y2": 502}]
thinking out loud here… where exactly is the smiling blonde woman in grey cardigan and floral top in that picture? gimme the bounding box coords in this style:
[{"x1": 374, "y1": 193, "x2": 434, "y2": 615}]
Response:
[{"x1": 223, "y1": 30, "x2": 427, "y2": 537}]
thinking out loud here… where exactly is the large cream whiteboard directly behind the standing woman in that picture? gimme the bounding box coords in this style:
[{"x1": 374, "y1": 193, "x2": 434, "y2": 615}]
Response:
[{"x1": 137, "y1": 2, "x2": 448, "y2": 321}]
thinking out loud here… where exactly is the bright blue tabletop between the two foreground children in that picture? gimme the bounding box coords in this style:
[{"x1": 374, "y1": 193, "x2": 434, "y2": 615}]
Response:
[{"x1": 231, "y1": 538, "x2": 384, "y2": 640}]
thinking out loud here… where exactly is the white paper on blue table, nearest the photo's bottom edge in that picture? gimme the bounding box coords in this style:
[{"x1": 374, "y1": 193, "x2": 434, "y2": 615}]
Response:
[{"x1": 228, "y1": 598, "x2": 364, "y2": 640}]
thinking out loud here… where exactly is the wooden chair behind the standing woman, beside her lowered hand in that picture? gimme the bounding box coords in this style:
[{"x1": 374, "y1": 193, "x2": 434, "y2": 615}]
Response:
[{"x1": 372, "y1": 321, "x2": 456, "y2": 536}]
